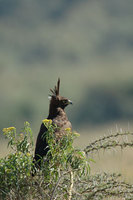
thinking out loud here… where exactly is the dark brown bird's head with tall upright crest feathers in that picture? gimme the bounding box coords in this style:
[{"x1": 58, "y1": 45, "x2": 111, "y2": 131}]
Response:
[{"x1": 49, "y1": 78, "x2": 72, "y2": 109}]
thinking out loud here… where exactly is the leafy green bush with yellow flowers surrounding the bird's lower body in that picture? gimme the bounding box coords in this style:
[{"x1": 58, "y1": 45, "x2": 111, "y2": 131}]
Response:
[{"x1": 0, "y1": 120, "x2": 90, "y2": 199}]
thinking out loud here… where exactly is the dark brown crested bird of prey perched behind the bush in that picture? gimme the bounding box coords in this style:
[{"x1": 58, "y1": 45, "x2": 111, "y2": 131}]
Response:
[{"x1": 34, "y1": 79, "x2": 72, "y2": 167}]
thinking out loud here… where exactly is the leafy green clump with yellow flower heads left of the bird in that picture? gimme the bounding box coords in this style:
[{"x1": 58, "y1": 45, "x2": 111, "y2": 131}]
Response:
[{"x1": 0, "y1": 122, "x2": 33, "y2": 199}]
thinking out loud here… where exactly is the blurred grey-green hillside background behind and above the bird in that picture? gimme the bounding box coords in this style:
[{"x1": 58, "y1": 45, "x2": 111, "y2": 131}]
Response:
[{"x1": 0, "y1": 0, "x2": 133, "y2": 177}]
